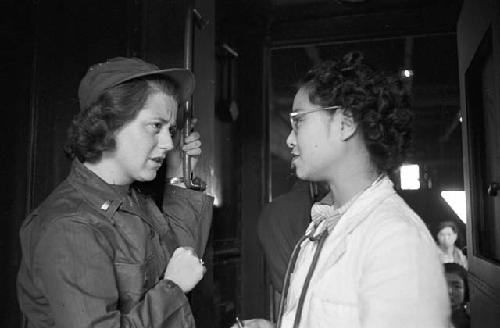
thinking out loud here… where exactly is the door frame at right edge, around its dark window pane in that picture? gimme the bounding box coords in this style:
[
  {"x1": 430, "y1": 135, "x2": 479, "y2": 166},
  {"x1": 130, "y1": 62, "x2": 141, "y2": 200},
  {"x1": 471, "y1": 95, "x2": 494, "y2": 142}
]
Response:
[{"x1": 457, "y1": 0, "x2": 500, "y2": 327}]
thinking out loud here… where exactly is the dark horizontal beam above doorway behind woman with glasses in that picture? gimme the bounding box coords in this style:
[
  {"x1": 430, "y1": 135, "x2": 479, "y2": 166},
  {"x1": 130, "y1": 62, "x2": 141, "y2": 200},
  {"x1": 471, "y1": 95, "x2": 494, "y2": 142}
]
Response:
[{"x1": 269, "y1": 0, "x2": 460, "y2": 47}]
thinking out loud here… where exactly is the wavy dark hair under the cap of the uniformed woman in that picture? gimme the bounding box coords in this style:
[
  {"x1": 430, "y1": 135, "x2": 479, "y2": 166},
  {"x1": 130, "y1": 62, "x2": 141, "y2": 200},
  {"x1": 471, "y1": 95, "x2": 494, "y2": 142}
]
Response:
[{"x1": 64, "y1": 75, "x2": 178, "y2": 163}]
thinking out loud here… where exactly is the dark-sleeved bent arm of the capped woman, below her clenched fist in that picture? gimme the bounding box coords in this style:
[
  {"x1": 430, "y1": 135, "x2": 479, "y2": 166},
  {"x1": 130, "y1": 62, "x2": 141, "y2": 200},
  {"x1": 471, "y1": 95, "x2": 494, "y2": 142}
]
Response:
[{"x1": 34, "y1": 218, "x2": 192, "y2": 328}]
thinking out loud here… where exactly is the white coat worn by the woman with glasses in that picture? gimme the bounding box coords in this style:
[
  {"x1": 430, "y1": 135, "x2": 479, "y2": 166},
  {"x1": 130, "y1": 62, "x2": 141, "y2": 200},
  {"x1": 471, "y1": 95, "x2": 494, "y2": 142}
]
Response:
[{"x1": 281, "y1": 178, "x2": 450, "y2": 328}]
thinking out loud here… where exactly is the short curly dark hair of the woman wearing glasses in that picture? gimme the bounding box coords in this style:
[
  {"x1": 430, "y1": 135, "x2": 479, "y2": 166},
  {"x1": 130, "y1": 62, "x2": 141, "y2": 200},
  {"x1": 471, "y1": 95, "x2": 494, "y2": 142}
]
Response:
[{"x1": 299, "y1": 52, "x2": 413, "y2": 173}]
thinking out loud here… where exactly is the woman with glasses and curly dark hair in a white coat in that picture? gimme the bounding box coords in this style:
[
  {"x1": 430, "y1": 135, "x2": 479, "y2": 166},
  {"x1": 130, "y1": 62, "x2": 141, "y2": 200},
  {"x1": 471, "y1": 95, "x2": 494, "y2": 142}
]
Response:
[{"x1": 234, "y1": 53, "x2": 449, "y2": 328}]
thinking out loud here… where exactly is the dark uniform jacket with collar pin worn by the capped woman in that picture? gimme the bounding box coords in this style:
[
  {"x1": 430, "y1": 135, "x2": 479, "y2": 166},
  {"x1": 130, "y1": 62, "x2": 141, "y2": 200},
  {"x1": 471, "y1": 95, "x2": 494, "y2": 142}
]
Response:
[{"x1": 17, "y1": 161, "x2": 212, "y2": 328}]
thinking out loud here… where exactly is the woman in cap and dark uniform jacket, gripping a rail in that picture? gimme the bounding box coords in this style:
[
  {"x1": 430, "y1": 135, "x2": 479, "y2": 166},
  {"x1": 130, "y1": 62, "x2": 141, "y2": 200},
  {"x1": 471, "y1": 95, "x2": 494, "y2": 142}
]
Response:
[{"x1": 18, "y1": 58, "x2": 212, "y2": 328}]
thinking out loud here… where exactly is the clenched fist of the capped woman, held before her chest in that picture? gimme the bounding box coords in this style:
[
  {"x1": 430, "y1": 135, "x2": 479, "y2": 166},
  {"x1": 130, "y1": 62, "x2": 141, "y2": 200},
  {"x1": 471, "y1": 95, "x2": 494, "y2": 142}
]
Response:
[{"x1": 163, "y1": 247, "x2": 206, "y2": 293}]
